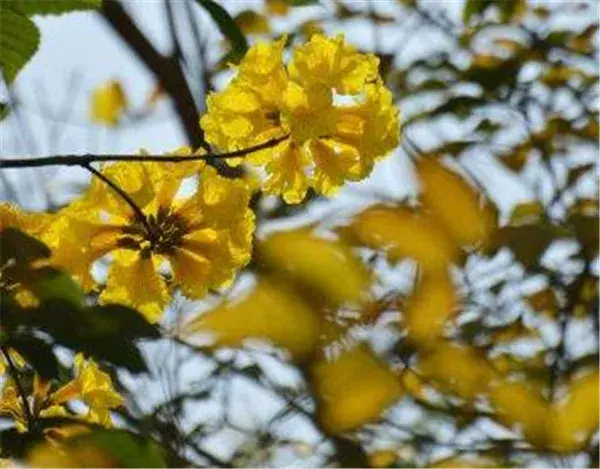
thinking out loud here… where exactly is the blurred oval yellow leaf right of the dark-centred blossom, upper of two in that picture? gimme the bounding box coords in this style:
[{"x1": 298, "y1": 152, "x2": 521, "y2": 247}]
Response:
[{"x1": 258, "y1": 229, "x2": 370, "y2": 306}]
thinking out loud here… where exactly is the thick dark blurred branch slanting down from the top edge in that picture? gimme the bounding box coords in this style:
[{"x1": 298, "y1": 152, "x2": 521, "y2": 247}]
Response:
[{"x1": 101, "y1": 0, "x2": 210, "y2": 151}]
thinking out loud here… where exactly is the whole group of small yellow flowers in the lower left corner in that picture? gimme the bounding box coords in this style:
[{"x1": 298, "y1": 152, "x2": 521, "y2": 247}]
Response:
[{"x1": 0, "y1": 354, "x2": 123, "y2": 436}]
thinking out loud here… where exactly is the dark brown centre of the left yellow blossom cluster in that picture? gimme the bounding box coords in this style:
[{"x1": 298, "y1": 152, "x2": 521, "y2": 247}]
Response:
[{"x1": 119, "y1": 207, "x2": 188, "y2": 254}]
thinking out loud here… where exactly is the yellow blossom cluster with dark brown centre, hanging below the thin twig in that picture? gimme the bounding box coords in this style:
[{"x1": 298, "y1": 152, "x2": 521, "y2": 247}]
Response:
[{"x1": 44, "y1": 162, "x2": 254, "y2": 321}]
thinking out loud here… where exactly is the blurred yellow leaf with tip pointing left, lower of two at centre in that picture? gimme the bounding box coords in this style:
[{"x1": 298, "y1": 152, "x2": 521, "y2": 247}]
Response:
[{"x1": 183, "y1": 278, "x2": 320, "y2": 360}]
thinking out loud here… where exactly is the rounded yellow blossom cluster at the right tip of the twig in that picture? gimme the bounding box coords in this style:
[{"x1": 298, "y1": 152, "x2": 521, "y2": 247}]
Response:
[{"x1": 201, "y1": 34, "x2": 399, "y2": 203}]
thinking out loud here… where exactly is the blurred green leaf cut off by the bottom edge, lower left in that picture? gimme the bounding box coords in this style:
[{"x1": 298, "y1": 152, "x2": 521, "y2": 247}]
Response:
[{"x1": 84, "y1": 430, "x2": 166, "y2": 467}]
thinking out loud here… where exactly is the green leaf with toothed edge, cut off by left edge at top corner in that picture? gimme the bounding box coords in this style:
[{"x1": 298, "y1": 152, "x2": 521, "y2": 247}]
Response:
[{"x1": 0, "y1": 2, "x2": 40, "y2": 85}]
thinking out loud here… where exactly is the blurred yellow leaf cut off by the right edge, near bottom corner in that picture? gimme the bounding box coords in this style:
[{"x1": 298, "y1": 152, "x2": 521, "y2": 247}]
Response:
[{"x1": 548, "y1": 370, "x2": 600, "y2": 452}]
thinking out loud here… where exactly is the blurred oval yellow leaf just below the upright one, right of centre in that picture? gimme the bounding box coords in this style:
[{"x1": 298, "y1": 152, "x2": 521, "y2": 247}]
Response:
[{"x1": 418, "y1": 342, "x2": 494, "y2": 400}]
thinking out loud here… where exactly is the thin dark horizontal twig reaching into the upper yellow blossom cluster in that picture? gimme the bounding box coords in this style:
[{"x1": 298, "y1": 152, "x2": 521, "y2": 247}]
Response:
[{"x1": 0, "y1": 135, "x2": 289, "y2": 169}]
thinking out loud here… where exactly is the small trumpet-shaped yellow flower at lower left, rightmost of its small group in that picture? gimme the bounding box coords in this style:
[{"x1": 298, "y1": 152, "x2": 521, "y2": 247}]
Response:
[{"x1": 50, "y1": 353, "x2": 123, "y2": 427}]
